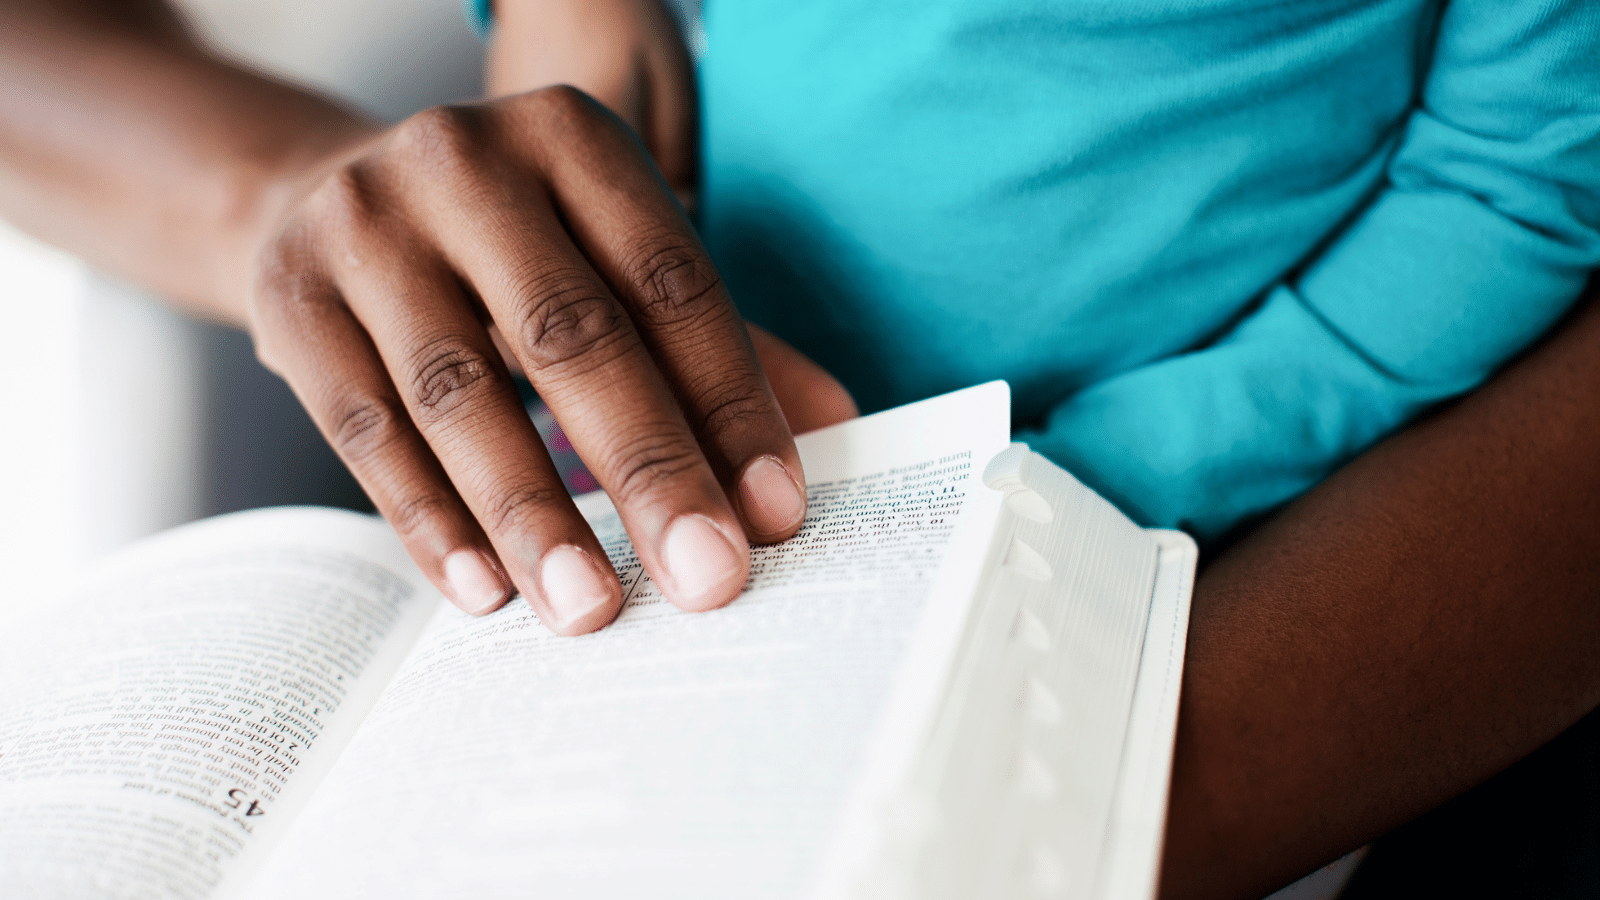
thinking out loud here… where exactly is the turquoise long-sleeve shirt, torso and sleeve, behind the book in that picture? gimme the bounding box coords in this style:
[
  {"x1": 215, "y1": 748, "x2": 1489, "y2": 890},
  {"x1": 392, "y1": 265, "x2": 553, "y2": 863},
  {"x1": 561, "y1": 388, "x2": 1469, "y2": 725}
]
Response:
[{"x1": 701, "y1": 0, "x2": 1600, "y2": 536}]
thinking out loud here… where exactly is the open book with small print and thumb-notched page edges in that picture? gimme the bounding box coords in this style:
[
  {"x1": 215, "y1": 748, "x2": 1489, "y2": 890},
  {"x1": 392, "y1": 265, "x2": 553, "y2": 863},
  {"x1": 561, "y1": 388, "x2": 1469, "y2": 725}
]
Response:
[{"x1": 0, "y1": 383, "x2": 1195, "y2": 900}]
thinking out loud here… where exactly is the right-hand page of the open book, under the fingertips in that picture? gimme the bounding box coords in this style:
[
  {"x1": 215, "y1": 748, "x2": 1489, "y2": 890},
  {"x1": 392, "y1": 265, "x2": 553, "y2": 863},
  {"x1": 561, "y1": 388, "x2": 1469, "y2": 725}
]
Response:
[{"x1": 243, "y1": 384, "x2": 1008, "y2": 900}]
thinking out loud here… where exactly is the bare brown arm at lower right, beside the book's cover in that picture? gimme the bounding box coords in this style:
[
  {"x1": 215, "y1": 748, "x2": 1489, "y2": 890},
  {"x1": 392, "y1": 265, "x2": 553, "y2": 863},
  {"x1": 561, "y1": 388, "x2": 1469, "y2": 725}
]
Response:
[{"x1": 1162, "y1": 285, "x2": 1600, "y2": 898}]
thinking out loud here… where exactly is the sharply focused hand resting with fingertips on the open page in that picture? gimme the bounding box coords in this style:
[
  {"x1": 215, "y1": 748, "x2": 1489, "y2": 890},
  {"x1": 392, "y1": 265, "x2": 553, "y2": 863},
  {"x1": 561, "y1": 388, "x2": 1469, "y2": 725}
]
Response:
[{"x1": 250, "y1": 88, "x2": 805, "y2": 634}]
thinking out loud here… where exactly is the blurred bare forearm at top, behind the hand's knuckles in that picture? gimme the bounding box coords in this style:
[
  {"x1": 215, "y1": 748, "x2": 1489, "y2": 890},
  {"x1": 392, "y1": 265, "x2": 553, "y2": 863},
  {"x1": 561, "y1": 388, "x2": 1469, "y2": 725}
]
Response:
[{"x1": 486, "y1": 0, "x2": 698, "y2": 210}]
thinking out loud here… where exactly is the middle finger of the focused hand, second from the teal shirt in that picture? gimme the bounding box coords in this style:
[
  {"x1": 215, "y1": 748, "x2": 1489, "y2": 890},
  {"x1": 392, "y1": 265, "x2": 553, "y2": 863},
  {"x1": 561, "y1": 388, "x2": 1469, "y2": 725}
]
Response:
[{"x1": 434, "y1": 171, "x2": 750, "y2": 610}]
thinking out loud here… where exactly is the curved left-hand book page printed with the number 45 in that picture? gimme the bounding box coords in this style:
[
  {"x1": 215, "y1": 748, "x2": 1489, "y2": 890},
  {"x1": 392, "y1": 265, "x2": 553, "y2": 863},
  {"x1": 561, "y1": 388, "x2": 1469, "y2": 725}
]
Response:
[{"x1": 0, "y1": 509, "x2": 435, "y2": 900}]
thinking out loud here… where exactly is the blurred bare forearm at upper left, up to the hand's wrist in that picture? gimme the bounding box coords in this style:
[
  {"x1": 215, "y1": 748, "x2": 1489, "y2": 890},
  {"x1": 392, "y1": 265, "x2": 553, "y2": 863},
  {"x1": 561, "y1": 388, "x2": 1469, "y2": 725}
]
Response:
[{"x1": 0, "y1": 0, "x2": 373, "y2": 323}]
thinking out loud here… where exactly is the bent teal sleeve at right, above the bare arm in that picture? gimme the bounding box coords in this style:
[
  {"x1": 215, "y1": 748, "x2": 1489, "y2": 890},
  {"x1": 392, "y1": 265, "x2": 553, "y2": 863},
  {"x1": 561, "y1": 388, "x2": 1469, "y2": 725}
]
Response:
[{"x1": 1018, "y1": 0, "x2": 1600, "y2": 536}]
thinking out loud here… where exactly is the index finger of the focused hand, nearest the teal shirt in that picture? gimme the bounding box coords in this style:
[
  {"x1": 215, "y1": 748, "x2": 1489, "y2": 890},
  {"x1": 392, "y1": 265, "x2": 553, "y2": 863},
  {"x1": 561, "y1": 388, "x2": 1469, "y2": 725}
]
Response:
[{"x1": 512, "y1": 91, "x2": 806, "y2": 541}]
